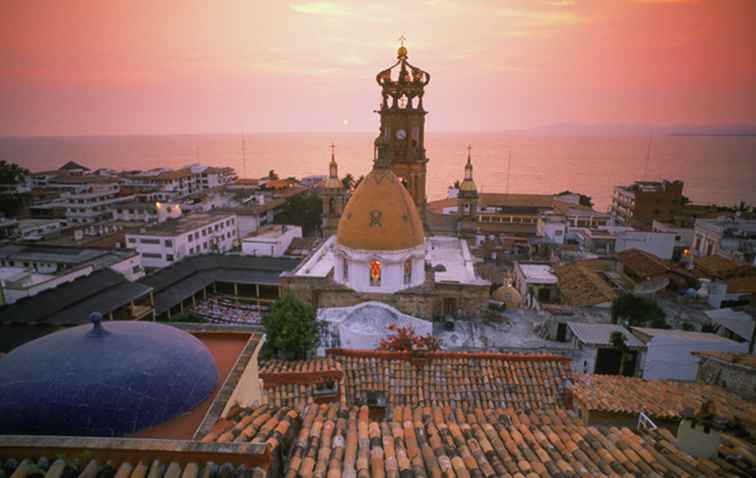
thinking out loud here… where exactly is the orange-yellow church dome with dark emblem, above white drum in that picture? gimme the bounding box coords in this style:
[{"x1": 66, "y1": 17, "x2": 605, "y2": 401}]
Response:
[{"x1": 336, "y1": 168, "x2": 425, "y2": 251}]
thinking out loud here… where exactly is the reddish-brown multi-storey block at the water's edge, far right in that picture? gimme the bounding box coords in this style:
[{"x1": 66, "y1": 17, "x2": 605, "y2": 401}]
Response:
[{"x1": 611, "y1": 180, "x2": 683, "y2": 226}]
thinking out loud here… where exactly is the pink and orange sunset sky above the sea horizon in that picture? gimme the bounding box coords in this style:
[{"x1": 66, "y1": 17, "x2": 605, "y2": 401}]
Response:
[{"x1": 0, "y1": 0, "x2": 756, "y2": 135}]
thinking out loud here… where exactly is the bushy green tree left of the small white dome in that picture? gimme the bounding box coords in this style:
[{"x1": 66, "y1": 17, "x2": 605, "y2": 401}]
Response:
[{"x1": 262, "y1": 294, "x2": 320, "y2": 360}]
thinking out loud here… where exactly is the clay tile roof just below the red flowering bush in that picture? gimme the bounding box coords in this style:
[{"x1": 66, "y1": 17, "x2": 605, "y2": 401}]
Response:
[{"x1": 329, "y1": 349, "x2": 571, "y2": 410}]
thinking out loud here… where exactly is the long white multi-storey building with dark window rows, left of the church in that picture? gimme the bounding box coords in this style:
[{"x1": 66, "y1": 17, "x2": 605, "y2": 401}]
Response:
[{"x1": 126, "y1": 214, "x2": 238, "y2": 268}]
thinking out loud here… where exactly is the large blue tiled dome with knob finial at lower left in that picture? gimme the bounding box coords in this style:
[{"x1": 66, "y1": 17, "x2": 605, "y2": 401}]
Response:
[{"x1": 0, "y1": 314, "x2": 218, "y2": 436}]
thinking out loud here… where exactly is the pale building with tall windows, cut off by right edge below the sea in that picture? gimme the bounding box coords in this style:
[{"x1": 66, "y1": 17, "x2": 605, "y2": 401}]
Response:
[{"x1": 693, "y1": 217, "x2": 756, "y2": 265}]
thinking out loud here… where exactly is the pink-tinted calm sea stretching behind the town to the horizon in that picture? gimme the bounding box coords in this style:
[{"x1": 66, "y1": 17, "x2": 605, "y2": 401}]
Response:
[{"x1": 0, "y1": 132, "x2": 756, "y2": 210}]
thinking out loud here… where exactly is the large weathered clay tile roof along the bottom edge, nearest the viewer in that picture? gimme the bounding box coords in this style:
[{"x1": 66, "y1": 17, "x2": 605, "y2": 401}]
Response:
[{"x1": 203, "y1": 403, "x2": 756, "y2": 478}]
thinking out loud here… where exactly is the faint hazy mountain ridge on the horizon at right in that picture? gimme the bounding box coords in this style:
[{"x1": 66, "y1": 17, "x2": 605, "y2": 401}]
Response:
[{"x1": 529, "y1": 123, "x2": 756, "y2": 136}]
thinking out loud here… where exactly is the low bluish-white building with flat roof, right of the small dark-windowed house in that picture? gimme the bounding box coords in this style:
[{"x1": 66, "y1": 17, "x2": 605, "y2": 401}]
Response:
[{"x1": 631, "y1": 327, "x2": 748, "y2": 382}]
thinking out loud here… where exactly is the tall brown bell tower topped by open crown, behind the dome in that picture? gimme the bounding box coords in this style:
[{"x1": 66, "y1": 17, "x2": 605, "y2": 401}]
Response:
[{"x1": 373, "y1": 37, "x2": 430, "y2": 211}]
